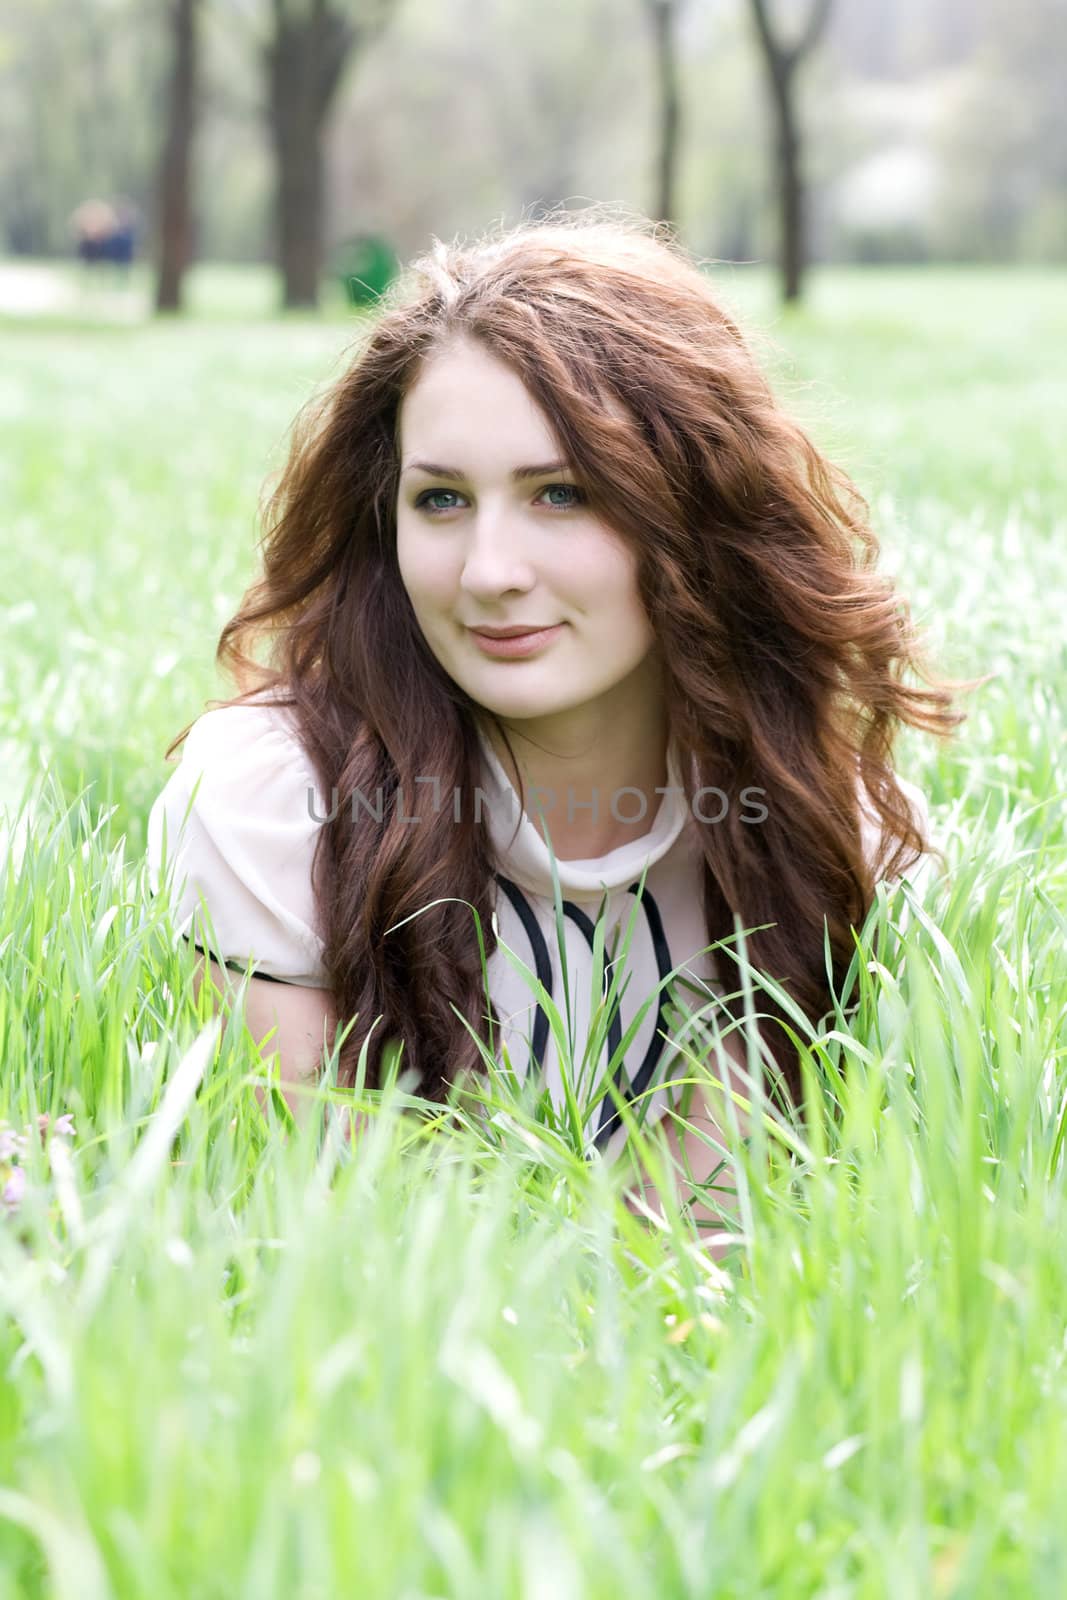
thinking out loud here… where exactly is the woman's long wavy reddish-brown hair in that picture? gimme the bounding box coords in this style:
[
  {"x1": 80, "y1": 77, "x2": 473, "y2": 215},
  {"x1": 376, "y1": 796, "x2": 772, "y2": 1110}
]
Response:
[{"x1": 168, "y1": 210, "x2": 985, "y2": 1102}]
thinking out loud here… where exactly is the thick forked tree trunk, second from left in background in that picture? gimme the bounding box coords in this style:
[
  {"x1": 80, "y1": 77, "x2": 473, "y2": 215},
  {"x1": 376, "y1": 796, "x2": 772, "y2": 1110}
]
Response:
[{"x1": 266, "y1": 0, "x2": 397, "y2": 307}]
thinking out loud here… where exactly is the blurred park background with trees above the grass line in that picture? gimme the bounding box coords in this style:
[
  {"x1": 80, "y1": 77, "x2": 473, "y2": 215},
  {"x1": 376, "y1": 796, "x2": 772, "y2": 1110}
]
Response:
[{"x1": 0, "y1": 0, "x2": 1067, "y2": 317}]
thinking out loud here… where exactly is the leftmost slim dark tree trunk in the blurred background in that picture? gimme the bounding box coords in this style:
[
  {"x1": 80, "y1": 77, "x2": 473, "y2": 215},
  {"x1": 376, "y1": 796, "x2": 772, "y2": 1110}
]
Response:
[{"x1": 155, "y1": 0, "x2": 197, "y2": 310}]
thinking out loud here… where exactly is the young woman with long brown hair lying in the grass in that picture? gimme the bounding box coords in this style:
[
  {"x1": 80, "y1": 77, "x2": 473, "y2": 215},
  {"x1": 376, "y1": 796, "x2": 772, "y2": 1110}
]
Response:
[{"x1": 150, "y1": 209, "x2": 963, "y2": 1235}]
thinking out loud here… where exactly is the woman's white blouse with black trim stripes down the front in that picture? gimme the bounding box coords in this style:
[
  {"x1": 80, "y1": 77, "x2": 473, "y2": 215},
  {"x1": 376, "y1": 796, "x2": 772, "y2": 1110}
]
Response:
[{"x1": 147, "y1": 699, "x2": 931, "y2": 1160}]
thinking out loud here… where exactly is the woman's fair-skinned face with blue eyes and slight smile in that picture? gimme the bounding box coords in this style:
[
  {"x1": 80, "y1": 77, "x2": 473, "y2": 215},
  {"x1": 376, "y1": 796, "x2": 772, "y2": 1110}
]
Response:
[{"x1": 397, "y1": 338, "x2": 654, "y2": 732}]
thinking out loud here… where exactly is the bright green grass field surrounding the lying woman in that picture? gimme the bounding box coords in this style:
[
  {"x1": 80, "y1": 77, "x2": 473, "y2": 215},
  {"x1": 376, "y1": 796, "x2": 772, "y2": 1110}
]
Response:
[{"x1": 0, "y1": 269, "x2": 1067, "y2": 1600}]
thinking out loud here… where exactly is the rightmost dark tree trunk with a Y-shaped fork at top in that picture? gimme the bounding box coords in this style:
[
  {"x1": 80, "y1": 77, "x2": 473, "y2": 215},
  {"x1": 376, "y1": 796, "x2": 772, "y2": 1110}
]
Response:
[{"x1": 752, "y1": 0, "x2": 832, "y2": 301}]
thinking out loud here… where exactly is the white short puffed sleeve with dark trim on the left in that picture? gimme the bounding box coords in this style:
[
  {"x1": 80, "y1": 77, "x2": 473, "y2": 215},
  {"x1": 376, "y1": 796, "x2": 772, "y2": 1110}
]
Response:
[{"x1": 147, "y1": 702, "x2": 328, "y2": 987}]
